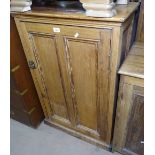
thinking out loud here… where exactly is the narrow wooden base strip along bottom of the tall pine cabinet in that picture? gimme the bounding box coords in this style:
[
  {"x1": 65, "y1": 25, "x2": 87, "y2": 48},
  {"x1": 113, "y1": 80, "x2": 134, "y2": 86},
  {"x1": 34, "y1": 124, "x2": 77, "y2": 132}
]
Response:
[{"x1": 44, "y1": 119, "x2": 111, "y2": 151}]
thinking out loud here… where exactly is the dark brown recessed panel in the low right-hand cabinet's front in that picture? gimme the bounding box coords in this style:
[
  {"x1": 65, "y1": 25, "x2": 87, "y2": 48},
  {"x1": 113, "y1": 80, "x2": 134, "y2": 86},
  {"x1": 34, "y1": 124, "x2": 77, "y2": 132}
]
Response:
[{"x1": 125, "y1": 87, "x2": 144, "y2": 155}]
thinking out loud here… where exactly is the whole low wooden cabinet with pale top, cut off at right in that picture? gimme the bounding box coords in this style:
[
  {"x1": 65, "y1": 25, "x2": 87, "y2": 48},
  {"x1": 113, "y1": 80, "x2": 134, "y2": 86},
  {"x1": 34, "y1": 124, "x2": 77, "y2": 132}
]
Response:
[{"x1": 113, "y1": 43, "x2": 144, "y2": 155}]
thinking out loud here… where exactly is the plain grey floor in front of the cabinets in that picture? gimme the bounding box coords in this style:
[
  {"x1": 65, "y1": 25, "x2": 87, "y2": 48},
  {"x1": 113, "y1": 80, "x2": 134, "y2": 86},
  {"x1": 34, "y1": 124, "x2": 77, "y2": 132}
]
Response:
[{"x1": 10, "y1": 120, "x2": 120, "y2": 155}]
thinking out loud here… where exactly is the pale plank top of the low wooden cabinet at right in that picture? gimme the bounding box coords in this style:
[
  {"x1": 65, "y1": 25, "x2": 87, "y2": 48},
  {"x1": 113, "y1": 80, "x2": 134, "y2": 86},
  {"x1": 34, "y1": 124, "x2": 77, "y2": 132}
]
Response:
[{"x1": 119, "y1": 42, "x2": 144, "y2": 79}]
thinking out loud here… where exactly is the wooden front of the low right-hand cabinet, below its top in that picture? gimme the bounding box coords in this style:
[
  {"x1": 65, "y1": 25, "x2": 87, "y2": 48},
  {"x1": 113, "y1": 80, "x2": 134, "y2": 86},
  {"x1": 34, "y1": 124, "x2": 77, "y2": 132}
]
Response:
[{"x1": 113, "y1": 78, "x2": 144, "y2": 155}]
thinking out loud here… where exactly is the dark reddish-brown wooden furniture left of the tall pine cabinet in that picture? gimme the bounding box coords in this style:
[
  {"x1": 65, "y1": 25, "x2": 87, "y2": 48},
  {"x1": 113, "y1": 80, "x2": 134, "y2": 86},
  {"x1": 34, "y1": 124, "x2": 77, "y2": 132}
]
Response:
[{"x1": 10, "y1": 18, "x2": 44, "y2": 127}]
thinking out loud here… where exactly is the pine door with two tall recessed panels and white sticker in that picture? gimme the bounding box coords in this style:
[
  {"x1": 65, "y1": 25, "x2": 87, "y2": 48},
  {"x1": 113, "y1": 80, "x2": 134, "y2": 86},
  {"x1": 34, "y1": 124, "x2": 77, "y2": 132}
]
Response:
[{"x1": 19, "y1": 22, "x2": 111, "y2": 143}]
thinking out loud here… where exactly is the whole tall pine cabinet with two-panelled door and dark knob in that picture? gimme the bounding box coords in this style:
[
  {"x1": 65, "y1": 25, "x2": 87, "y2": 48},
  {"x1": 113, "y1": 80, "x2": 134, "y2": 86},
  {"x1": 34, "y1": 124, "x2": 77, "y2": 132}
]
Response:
[{"x1": 12, "y1": 3, "x2": 138, "y2": 149}]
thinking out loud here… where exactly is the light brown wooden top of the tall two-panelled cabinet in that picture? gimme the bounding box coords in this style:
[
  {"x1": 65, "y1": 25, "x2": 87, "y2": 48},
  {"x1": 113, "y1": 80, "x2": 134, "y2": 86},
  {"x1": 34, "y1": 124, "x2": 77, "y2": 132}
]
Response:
[{"x1": 11, "y1": 2, "x2": 139, "y2": 23}]
